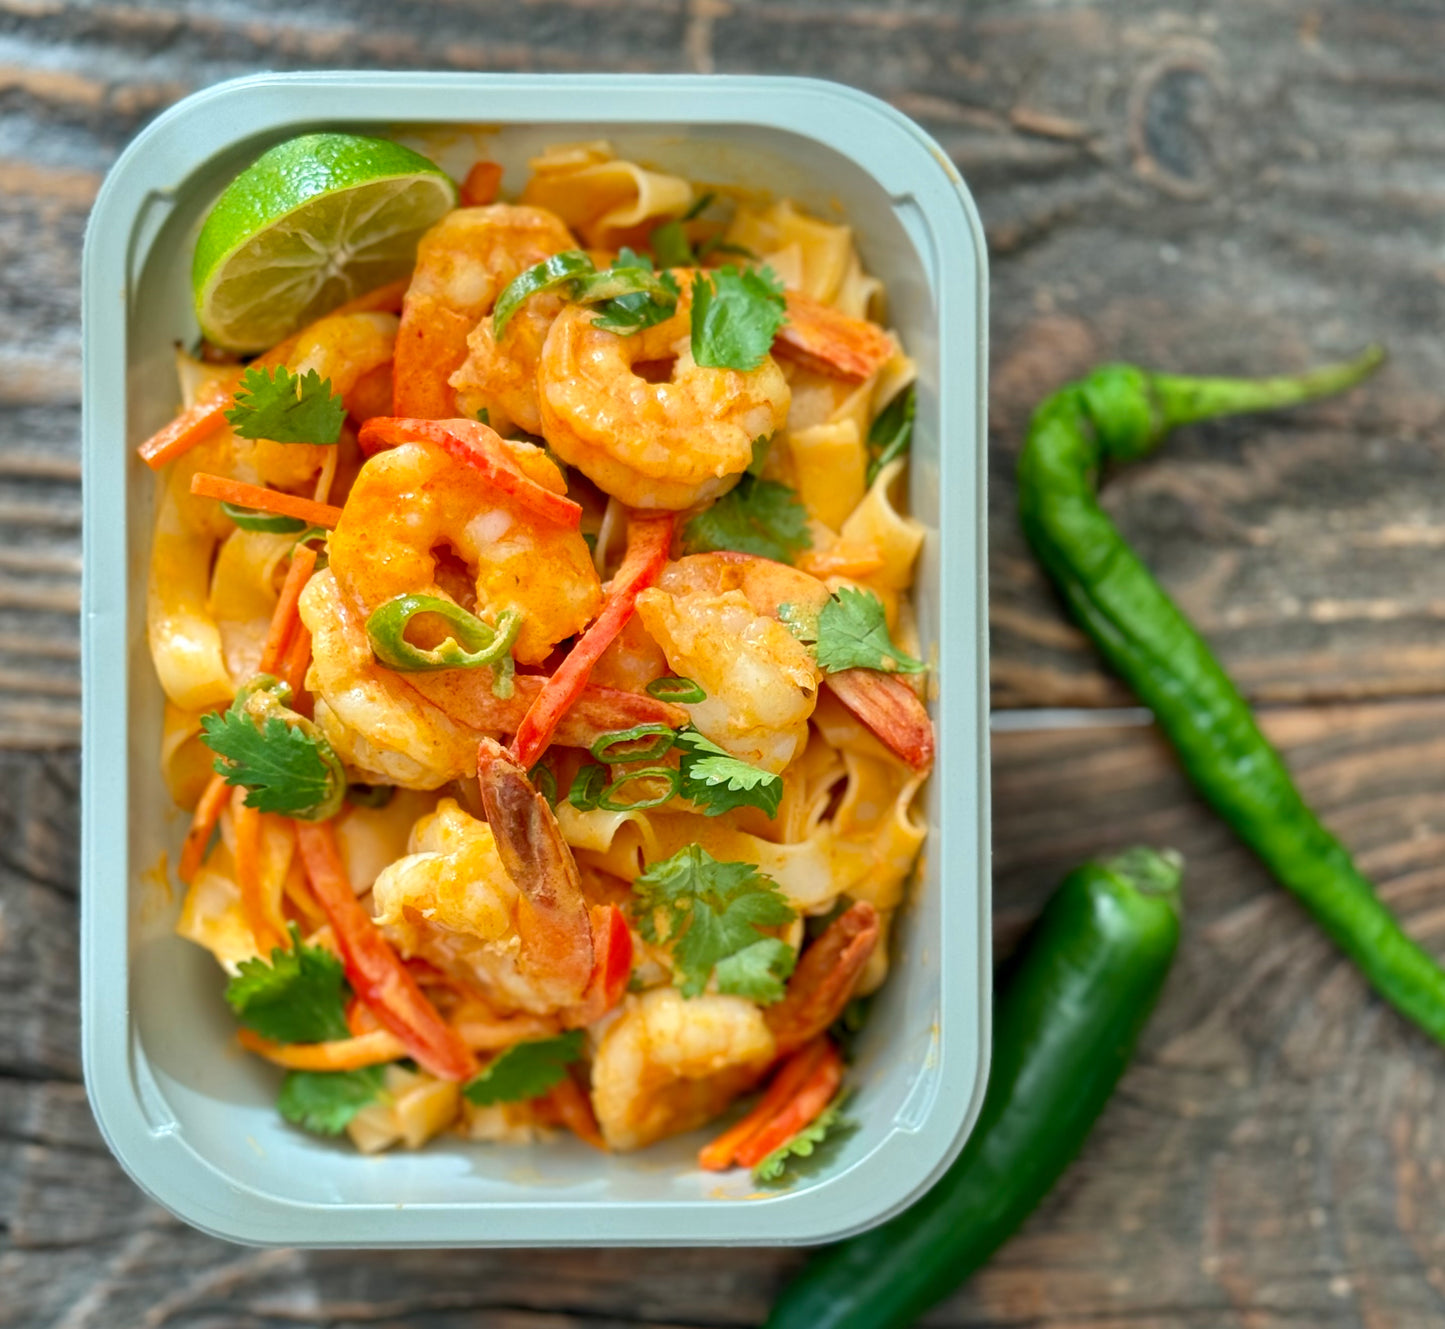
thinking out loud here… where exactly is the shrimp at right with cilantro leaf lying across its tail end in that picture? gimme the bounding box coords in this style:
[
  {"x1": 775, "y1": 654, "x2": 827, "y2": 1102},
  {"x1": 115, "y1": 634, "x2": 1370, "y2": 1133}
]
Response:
[{"x1": 637, "y1": 552, "x2": 933, "y2": 771}]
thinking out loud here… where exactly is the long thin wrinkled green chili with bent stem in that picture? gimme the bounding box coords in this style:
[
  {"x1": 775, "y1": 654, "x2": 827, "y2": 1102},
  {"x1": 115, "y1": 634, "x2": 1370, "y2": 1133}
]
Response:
[{"x1": 1019, "y1": 347, "x2": 1445, "y2": 1042}]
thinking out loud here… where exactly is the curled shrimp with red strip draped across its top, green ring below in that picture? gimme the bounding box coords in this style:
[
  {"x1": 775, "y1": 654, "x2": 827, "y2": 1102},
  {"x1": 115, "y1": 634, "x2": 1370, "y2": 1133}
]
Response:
[{"x1": 329, "y1": 426, "x2": 603, "y2": 665}]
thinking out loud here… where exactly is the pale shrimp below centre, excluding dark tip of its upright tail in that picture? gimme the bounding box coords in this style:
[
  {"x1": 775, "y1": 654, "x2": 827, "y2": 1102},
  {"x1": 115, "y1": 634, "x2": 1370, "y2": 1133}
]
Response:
[{"x1": 371, "y1": 799, "x2": 592, "y2": 1016}]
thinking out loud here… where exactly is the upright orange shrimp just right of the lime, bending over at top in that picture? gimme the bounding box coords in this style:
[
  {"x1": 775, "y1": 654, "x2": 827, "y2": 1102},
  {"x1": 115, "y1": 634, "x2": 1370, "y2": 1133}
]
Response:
[{"x1": 396, "y1": 204, "x2": 577, "y2": 420}]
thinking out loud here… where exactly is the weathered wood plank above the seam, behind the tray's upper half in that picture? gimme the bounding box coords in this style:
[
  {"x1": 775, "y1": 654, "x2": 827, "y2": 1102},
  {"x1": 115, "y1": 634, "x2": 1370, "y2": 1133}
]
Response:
[{"x1": 0, "y1": 0, "x2": 1445, "y2": 744}]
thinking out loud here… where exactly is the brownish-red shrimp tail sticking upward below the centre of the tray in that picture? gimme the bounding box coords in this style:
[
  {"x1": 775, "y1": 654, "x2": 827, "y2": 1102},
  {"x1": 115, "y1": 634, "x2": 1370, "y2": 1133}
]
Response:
[{"x1": 477, "y1": 738, "x2": 592, "y2": 1005}]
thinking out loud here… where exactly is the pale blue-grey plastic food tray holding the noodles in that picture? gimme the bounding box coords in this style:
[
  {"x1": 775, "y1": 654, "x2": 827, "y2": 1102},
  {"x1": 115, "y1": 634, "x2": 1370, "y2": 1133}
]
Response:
[{"x1": 81, "y1": 72, "x2": 990, "y2": 1247}]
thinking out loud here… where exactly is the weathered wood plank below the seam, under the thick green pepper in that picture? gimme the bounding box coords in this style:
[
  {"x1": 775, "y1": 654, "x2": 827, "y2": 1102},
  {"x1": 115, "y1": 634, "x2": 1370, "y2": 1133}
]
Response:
[{"x1": 0, "y1": 701, "x2": 1445, "y2": 1329}]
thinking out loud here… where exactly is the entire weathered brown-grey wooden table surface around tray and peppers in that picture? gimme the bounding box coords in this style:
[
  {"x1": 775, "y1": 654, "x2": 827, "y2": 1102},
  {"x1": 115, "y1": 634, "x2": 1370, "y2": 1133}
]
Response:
[{"x1": 0, "y1": 0, "x2": 1445, "y2": 1329}]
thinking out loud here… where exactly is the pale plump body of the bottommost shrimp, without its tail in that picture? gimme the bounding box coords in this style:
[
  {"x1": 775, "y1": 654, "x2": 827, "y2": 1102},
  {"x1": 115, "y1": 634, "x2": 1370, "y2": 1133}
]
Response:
[{"x1": 592, "y1": 988, "x2": 777, "y2": 1148}]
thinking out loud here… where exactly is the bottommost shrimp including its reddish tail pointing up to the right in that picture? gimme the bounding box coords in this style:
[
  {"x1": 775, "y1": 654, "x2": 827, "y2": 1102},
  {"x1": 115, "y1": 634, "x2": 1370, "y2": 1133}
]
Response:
[{"x1": 592, "y1": 903, "x2": 879, "y2": 1148}]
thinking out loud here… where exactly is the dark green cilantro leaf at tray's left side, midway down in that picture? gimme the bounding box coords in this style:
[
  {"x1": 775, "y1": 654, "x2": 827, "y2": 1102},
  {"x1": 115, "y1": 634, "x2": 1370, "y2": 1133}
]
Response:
[{"x1": 201, "y1": 698, "x2": 345, "y2": 819}]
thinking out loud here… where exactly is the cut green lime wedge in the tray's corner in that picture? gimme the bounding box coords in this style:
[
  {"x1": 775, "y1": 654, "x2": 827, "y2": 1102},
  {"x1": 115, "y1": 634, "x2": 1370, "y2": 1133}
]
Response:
[{"x1": 191, "y1": 134, "x2": 457, "y2": 351}]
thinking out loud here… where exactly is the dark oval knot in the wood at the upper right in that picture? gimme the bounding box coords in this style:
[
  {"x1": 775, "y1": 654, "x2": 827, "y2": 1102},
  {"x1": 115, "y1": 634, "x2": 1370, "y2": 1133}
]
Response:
[{"x1": 1129, "y1": 43, "x2": 1228, "y2": 198}]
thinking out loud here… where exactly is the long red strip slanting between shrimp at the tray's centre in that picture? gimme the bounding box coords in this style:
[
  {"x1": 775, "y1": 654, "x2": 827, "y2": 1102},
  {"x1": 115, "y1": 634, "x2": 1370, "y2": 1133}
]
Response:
[{"x1": 512, "y1": 513, "x2": 678, "y2": 770}]
